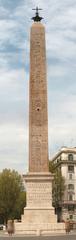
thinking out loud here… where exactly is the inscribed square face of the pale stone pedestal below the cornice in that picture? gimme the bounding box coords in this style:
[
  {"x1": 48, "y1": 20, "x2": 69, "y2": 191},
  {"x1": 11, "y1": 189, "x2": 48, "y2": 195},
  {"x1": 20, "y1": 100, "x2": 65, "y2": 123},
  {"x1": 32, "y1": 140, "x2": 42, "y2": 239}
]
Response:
[{"x1": 27, "y1": 181, "x2": 52, "y2": 208}]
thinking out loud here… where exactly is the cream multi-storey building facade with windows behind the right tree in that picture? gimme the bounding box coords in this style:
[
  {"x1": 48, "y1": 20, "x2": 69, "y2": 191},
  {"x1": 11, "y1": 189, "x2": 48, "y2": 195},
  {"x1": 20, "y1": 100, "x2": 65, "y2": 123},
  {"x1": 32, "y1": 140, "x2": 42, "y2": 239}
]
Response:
[{"x1": 52, "y1": 147, "x2": 76, "y2": 221}]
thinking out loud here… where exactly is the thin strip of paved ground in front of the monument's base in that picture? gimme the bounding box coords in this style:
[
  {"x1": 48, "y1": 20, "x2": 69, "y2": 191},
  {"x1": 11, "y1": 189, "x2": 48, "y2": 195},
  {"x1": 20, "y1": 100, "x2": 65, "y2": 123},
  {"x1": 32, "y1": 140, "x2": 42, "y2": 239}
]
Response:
[{"x1": 0, "y1": 233, "x2": 76, "y2": 240}]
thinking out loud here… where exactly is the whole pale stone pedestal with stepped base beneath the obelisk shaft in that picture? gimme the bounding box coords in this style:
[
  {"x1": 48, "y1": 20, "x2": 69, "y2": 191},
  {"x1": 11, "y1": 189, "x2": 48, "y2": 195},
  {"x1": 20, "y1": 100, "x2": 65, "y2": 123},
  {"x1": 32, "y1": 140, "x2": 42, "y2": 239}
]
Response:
[{"x1": 15, "y1": 173, "x2": 65, "y2": 235}]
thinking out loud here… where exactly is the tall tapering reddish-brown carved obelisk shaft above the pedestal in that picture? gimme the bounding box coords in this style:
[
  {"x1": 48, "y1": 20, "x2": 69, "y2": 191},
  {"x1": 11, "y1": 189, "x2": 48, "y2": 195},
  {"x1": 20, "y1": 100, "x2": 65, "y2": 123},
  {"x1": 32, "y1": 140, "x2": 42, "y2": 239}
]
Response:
[{"x1": 29, "y1": 7, "x2": 49, "y2": 173}]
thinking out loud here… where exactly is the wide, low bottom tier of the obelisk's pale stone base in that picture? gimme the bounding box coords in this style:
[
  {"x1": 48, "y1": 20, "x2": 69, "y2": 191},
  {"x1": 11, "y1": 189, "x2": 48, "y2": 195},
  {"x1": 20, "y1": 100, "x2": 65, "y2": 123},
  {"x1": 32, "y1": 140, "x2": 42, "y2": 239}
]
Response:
[{"x1": 15, "y1": 222, "x2": 65, "y2": 236}]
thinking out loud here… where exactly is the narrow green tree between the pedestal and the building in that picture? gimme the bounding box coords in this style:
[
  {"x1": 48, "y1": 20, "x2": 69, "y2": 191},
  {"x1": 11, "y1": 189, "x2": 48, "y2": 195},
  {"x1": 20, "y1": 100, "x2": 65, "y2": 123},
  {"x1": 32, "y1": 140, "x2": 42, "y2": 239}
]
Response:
[{"x1": 49, "y1": 161, "x2": 65, "y2": 220}]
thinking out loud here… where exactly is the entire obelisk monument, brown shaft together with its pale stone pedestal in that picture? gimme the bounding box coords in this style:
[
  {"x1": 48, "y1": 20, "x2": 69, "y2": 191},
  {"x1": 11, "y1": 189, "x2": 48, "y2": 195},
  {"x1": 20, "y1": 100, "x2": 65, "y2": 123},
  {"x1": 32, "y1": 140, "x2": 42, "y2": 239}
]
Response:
[{"x1": 15, "y1": 8, "x2": 62, "y2": 234}]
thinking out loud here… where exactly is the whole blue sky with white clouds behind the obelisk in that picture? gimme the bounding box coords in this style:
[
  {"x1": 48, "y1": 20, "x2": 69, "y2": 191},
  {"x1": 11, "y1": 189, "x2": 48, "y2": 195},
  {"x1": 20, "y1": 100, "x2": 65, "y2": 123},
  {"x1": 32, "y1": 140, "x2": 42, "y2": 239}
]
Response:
[{"x1": 0, "y1": 0, "x2": 76, "y2": 173}]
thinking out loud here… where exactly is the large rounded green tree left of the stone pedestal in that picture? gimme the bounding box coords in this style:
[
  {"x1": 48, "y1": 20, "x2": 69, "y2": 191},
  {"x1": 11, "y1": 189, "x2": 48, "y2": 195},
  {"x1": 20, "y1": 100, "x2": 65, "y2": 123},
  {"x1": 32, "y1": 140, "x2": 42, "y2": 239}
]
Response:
[{"x1": 0, "y1": 169, "x2": 26, "y2": 223}]
